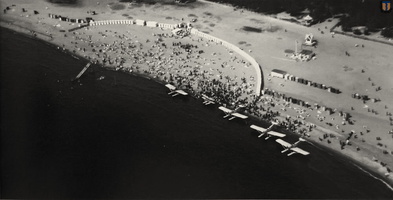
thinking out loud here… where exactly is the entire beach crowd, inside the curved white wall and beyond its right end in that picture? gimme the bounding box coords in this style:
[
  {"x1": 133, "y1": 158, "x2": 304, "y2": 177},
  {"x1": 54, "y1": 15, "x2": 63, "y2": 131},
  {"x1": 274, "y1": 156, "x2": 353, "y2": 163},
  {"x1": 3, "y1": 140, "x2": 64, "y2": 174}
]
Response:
[{"x1": 49, "y1": 15, "x2": 393, "y2": 177}]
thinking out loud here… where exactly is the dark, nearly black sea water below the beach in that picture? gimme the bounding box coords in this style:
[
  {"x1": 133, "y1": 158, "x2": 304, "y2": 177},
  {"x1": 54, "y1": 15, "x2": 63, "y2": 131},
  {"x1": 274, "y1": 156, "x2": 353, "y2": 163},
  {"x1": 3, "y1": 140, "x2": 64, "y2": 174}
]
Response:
[{"x1": 1, "y1": 29, "x2": 393, "y2": 198}]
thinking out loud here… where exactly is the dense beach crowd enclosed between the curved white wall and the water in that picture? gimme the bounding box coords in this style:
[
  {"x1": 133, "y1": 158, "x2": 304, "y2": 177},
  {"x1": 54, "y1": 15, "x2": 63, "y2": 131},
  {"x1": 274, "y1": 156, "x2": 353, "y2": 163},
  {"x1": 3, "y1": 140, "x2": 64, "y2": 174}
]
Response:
[{"x1": 68, "y1": 26, "x2": 256, "y2": 106}]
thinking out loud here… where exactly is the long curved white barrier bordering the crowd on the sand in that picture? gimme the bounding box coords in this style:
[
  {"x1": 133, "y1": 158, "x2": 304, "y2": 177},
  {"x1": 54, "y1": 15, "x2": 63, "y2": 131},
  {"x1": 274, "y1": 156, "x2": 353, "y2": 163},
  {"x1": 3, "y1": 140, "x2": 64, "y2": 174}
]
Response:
[{"x1": 89, "y1": 19, "x2": 262, "y2": 96}]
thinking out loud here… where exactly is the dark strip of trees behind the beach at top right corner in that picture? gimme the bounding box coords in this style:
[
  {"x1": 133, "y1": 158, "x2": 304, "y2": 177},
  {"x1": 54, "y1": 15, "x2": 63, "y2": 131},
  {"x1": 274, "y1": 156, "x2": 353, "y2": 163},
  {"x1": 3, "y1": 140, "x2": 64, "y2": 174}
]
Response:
[{"x1": 205, "y1": 0, "x2": 393, "y2": 37}]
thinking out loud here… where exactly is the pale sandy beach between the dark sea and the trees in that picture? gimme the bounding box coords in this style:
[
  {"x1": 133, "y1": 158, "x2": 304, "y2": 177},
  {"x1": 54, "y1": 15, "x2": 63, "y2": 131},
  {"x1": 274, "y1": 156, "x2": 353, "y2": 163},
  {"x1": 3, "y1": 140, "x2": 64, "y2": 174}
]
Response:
[{"x1": 0, "y1": 0, "x2": 393, "y2": 188}]
